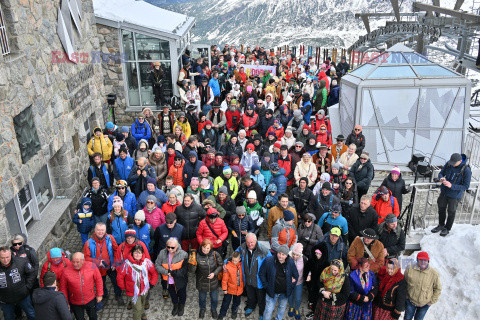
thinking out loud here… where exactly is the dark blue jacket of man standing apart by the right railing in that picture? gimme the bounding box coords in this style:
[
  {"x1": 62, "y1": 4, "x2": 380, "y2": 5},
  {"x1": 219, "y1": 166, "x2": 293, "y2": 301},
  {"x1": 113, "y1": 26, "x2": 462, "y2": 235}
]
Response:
[{"x1": 438, "y1": 154, "x2": 472, "y2": 199}]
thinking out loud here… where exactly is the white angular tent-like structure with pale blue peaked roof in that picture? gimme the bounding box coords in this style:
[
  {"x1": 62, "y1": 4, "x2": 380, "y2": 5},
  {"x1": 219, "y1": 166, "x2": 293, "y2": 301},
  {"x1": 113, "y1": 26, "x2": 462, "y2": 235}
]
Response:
[{"x1": 340, "y1": 44, "x2": 471, "y2": 165}]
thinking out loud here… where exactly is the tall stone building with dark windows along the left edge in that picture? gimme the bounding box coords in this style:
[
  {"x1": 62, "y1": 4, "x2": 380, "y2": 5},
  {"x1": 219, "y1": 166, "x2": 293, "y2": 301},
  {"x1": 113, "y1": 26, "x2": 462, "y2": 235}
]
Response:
[{"x1": 0, "y1": 0, "x2": 106, "y2": 257}]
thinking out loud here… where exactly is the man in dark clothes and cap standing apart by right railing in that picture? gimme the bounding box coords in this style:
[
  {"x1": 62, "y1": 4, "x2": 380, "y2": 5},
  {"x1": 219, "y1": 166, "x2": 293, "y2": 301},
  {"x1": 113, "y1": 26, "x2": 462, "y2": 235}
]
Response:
[{"x1": 432, "y1": 153, "x2": 472, "y2": 237}]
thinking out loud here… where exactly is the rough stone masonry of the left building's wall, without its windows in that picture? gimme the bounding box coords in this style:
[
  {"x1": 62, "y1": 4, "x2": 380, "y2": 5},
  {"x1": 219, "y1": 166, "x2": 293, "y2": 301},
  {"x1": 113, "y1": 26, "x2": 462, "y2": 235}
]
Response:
[{"x1": 0, "y1": 0, "x2": 106, "y2": 246}]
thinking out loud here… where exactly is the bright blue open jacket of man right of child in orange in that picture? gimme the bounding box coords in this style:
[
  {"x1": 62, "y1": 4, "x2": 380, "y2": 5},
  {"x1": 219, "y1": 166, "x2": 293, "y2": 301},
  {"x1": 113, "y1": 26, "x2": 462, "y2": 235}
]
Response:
[{"x1": 237, "y1": 242, "x2": 272, "y2": 289}]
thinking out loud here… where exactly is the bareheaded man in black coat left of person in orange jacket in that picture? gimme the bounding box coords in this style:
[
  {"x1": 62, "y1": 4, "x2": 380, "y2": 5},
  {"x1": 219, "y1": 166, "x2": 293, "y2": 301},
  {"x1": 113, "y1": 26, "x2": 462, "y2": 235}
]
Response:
[{"x1": 346, "y1": 195, "x2": 378, "y2": 243}]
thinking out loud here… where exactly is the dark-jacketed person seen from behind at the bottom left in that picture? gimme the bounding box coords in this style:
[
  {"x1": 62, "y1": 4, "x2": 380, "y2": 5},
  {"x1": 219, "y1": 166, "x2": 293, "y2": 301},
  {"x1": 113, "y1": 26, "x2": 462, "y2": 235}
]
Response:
[{"x1": 32, "y1": 271, "x2": 72, "y2": 320}]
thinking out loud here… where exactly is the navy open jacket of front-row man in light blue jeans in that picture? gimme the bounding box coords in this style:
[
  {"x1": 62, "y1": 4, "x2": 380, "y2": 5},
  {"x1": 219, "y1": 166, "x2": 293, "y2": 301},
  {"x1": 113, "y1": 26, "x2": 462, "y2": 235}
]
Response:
[{"x1": 259, "y1": 256, "x2": 298, "y2": 298}]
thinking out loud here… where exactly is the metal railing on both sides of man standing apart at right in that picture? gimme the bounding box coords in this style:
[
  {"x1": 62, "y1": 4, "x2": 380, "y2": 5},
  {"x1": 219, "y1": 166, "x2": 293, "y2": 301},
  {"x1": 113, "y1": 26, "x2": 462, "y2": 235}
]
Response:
[{"x1": 406, "y1": 181, "x2": 480, "y2": 233}]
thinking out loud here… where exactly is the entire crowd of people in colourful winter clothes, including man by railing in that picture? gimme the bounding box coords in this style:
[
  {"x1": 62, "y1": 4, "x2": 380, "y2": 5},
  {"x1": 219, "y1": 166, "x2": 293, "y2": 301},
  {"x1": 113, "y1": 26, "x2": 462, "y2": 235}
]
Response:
[{"x1": 0, "y1": 45, "x2": 476, "y2": 320}]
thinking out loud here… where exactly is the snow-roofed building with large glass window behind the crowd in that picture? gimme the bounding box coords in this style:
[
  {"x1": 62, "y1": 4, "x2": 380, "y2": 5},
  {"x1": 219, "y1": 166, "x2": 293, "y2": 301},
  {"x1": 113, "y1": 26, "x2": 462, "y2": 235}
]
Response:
[{"x1": 93, "y1": 0, "x2": 195, "y2": 123}]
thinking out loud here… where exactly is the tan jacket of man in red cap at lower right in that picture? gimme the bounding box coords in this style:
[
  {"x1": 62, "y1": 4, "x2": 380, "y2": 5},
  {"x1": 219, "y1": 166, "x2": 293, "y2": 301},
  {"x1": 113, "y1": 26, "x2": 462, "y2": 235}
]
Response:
[{"x1": 404, "y1": 264, "x2": 442, "y2": 307}]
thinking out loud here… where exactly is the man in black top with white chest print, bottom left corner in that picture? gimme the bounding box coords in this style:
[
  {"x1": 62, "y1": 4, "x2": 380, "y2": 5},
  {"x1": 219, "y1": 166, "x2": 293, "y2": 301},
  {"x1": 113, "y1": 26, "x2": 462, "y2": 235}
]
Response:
[{"x1": 0, "y1": 246, "x2": 37, "y2": 320}]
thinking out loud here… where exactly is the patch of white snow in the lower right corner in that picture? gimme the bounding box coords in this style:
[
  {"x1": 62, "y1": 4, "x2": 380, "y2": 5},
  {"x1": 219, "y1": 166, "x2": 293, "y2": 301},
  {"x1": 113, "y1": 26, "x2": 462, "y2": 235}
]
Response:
[{"x1": 402, "y1": 224, "x2": 480, "y2": 320}]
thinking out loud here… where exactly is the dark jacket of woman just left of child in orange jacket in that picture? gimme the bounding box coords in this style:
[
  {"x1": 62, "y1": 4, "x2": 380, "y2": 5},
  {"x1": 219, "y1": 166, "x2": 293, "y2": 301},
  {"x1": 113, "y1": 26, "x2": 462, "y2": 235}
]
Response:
[{"x1": 194, "y1": 250, "x2": 223, "y2": 292}]
